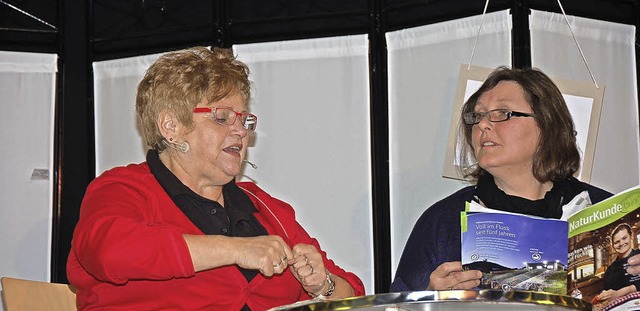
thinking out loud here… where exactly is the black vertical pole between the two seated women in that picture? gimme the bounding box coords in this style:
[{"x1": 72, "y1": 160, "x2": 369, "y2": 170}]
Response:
[{"x1": 369, "y1": 0, "x2": 391, "y2": 294}]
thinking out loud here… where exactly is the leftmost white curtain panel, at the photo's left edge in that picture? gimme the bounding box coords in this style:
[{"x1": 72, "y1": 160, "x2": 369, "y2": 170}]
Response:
[{"x1": 0, "y1": 52, "x2": 57, "y2": 290}]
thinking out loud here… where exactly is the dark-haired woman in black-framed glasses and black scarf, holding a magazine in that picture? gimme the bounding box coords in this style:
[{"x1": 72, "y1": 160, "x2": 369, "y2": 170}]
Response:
[{"x1": 391, "y1": 67, "x2": 611, "y2": 291}]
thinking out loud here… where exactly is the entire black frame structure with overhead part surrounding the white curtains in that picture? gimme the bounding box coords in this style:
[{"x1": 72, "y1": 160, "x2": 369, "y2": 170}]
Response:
[{"x1": 0, "y1": 0, "x2": 640, "y2": 293}]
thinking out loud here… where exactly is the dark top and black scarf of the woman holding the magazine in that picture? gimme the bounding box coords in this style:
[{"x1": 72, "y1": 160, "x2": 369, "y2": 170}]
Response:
[{"x1": 391, "y1": 175, "x2": 611, "y2": 292}]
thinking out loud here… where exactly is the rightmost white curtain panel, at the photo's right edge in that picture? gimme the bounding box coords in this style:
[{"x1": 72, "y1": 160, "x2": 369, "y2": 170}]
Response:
[{"x1": 530, "y1": 10, "x2": 640, "y2": 192}]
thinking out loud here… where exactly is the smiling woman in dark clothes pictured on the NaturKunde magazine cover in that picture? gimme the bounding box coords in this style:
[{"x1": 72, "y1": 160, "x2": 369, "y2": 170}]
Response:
[{"x1": 598, "y1": 223, "x2": 640, "y2": 301}]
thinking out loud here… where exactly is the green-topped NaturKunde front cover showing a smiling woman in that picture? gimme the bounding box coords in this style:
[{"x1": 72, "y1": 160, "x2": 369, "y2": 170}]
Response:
[{"x1": 568, "y1": 187, "x2": 640, "y2": 310}]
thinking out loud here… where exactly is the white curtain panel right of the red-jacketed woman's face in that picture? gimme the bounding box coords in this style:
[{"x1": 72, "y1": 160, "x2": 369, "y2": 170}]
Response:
[{"x1": 234, "y1": 35, "x2": 373, "y2": 293}]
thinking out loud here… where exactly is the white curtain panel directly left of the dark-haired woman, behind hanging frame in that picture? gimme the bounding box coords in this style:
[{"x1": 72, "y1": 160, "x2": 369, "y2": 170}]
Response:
[{"x1": 387, "y1": 11, "x2": 511, "y2": 274}]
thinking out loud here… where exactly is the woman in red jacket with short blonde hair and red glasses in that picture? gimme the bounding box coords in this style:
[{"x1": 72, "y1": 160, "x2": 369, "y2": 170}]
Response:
[{"x1": 67, "y1": 47, "x2": 364, "y2": 310}]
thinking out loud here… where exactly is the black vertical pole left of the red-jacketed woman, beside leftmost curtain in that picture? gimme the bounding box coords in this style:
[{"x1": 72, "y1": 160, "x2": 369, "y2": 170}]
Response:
[{"x1": 51, "y1": 1, "x2": 95, "y2": 283}]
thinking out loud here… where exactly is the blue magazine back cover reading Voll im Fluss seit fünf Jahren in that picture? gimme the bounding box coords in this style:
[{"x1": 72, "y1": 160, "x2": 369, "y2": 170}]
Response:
[{"x1": 461, "y1": 210, "x2": 568, "y2": 295}]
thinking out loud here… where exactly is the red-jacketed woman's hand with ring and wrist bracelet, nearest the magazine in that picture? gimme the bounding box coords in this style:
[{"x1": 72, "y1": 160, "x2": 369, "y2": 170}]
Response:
[{"x1": 290, "y1": 244, "x2": 328, "y2": 295}]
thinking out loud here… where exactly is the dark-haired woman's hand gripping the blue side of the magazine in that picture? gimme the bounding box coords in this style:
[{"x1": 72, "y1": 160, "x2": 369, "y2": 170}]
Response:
[{"x1": 427, "y1": 261, "x2": 482, "y2": 290}]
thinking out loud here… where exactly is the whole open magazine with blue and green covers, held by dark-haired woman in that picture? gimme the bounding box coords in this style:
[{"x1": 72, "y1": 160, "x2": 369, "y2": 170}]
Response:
[{"x1": 460, "y1": 186, "x2": 640, "y2": 310}]
